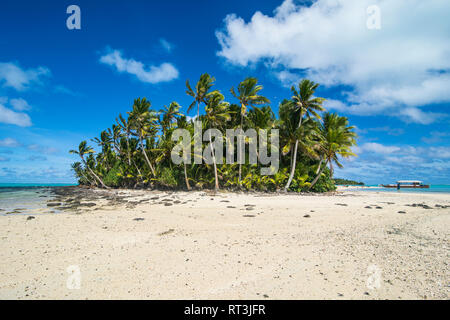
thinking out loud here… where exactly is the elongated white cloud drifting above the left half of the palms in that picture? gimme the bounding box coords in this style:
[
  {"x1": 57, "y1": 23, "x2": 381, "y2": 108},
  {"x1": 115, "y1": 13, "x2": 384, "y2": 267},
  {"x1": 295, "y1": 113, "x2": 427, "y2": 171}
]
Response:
[{"x1": 100, "y1": 50, "x2": 179, "y2": 83}]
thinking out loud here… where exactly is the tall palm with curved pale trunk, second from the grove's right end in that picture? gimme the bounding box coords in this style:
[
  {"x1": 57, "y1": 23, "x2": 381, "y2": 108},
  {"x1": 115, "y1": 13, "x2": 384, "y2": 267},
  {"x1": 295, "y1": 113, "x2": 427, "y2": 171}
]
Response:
[{"x1": 284, "y1": 79, "x2": 325, "y2": 191}]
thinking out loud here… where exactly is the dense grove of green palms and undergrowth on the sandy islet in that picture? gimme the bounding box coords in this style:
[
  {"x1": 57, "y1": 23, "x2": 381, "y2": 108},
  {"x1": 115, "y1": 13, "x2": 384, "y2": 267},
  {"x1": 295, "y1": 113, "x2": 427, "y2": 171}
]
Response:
[{"x1": 70, "y1": 73, "x2": 356, "y2": 192}]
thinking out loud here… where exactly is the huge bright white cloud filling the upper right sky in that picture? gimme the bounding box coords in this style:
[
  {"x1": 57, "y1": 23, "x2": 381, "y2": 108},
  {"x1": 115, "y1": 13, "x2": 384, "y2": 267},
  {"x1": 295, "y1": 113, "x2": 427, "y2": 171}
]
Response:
[{"x1": 216, "y1": 0, "x2": 450, "y2": 124}]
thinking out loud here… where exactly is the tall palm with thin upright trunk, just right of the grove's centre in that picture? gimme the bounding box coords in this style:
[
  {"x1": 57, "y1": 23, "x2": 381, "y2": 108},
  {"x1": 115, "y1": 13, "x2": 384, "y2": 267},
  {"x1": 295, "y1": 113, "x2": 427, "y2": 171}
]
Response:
[{"x1": 230, "y1": 77, "x2": 270, "y2": 185}]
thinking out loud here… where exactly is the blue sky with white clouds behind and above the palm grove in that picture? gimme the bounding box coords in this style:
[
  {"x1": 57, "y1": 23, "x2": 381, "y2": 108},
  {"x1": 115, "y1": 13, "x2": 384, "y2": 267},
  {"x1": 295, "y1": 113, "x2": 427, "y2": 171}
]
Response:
[{"x1": 0, "y1": 0, "x2": 450, "y2": 184}]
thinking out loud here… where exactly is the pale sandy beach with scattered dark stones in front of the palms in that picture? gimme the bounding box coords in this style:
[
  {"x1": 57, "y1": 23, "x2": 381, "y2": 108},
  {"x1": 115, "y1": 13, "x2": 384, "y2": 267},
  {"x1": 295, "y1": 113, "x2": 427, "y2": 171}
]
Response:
[{"x1": 0, "y1": 190, "x2": 450, "y2": 299}]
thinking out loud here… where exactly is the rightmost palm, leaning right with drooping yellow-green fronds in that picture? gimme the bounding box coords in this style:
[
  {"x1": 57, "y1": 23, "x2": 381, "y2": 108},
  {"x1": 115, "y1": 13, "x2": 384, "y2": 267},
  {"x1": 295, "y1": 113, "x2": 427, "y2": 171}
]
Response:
[{"x1": 310, "y1": 112, "x2": 356, "y2": 188}]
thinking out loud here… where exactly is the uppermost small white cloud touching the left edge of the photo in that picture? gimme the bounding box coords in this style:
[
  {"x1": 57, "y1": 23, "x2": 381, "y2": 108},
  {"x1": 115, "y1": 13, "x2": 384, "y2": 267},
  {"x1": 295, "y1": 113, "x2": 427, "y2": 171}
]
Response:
[{"x1": 0, "y1": 62, "x2": 50, "y2": 91}]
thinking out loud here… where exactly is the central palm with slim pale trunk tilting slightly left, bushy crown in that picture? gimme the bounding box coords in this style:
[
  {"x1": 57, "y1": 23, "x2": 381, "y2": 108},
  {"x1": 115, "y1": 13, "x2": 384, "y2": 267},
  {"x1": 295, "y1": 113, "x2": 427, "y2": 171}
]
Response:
[{"x1": 204, "y1": 92, "x2": 231, "y2": 190}]
